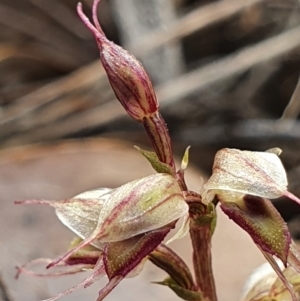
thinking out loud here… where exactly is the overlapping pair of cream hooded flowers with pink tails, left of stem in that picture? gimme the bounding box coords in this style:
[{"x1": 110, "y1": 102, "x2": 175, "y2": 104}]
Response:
[{"x1": 18, "y1": 173, "x2": 188, "y2": 301}]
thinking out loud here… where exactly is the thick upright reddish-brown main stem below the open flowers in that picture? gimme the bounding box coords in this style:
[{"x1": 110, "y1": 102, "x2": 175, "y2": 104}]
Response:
[{"x1": 190, "y1": 219, "x2": 217, "y2": 301}]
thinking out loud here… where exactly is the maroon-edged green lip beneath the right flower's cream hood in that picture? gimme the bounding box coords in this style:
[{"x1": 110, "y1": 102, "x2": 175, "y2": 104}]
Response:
[{"x1": 217, "y1": 192, "x2": 291, "y2": 265}]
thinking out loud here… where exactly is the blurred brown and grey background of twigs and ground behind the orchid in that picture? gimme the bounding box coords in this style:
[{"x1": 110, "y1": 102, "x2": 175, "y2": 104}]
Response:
[{"x1": 0, "y1": 0, "x2": 300, "y2": 301}]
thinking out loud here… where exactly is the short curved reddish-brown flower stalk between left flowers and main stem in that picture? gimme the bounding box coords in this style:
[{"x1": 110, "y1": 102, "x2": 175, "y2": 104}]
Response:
[{"x1": 149, "y1": 244, "x2": 195, "y2": 290}]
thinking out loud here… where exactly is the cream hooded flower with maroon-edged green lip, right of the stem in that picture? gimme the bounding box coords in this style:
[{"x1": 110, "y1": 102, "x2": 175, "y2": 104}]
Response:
[{"x1": 202, "y1": 148, "x2": 300, "y2": 301}]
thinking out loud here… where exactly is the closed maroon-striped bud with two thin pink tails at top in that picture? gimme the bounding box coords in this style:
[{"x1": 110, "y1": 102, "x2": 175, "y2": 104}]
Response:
[{"x1": 77, "y1": 0, "x2": 158, "y2": 121}]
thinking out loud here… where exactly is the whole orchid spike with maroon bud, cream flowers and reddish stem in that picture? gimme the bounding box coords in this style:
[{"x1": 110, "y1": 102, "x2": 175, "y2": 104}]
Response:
[{"x1": 17, "y1": 0, "x2": 300, "y2": 301}]
